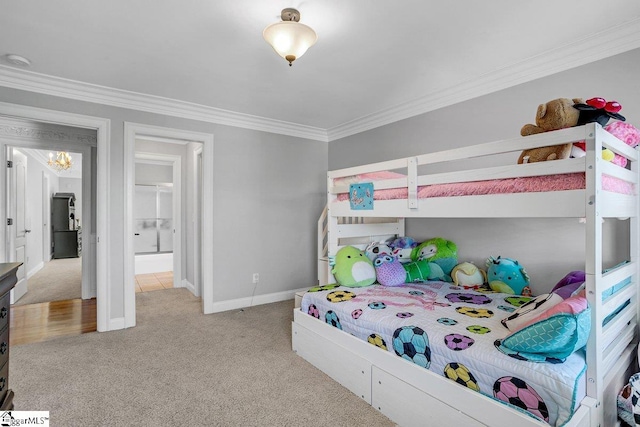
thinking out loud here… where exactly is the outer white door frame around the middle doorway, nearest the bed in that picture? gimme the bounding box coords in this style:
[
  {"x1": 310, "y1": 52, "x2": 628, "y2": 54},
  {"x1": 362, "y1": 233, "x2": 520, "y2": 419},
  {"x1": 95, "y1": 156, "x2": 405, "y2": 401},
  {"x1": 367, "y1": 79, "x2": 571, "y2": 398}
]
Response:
[{"x1": 124, "y1": 122, "x2": 214, "y2": 327}]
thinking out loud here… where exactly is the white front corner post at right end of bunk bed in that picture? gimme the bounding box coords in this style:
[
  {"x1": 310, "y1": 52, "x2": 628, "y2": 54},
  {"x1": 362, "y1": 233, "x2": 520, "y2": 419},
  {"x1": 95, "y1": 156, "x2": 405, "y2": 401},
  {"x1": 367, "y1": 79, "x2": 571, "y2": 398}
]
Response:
[{"x1": 585, "y1": 123, "x2": 605, "y2": 426}]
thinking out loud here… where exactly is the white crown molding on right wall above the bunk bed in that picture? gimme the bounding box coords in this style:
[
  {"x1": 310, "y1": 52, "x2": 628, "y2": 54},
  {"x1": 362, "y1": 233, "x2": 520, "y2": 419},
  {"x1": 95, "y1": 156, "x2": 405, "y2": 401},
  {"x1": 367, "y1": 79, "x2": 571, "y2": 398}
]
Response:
[{"x1": 327, "y1": 18, "x2": 640, "y2": 141}]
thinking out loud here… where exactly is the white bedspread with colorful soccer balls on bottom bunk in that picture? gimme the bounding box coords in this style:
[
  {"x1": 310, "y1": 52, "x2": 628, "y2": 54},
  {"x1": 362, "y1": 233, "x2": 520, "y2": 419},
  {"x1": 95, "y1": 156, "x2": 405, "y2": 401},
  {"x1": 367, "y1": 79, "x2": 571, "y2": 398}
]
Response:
[{"x1": 300, "y1": 282, "x2": 586, "y2": 426}]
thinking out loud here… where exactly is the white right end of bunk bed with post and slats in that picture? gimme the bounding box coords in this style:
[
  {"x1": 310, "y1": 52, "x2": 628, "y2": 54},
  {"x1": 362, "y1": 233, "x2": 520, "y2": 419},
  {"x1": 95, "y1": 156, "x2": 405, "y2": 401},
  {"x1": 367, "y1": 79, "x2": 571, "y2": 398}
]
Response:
[{"x1": 585, "y1": 123, "x2": 640, "y2": 427}]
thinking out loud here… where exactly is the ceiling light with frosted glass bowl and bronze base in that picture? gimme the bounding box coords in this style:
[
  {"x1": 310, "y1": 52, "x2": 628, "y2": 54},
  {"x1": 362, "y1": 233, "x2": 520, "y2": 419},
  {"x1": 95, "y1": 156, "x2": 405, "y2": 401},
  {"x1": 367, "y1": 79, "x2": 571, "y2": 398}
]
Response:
[{"x1": 262, "y1": 8, "x2": 318, "y2": 66}]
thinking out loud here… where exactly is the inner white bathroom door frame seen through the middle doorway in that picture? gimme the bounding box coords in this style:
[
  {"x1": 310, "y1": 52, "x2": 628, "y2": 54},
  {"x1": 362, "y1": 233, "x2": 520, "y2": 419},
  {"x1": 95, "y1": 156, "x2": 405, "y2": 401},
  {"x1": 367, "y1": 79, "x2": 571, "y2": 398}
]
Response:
[{"x1": 134, "y1": 151, "x2": 184, "y2": 288}]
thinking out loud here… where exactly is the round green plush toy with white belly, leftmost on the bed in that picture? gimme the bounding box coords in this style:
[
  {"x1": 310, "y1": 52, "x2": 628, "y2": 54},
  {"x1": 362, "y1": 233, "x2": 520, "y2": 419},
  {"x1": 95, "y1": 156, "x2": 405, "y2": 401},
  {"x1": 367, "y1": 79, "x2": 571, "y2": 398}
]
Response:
[{"x1": 329, "y1": 246, "x2": 376, "y2": 288}]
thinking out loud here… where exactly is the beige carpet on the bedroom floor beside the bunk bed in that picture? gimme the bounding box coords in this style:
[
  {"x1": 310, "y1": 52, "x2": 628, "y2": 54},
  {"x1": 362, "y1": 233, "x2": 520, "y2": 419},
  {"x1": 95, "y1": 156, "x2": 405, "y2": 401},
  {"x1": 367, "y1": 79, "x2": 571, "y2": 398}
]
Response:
[{"x1": 9, "y1": 288, "x2": 394, "y2": 427}]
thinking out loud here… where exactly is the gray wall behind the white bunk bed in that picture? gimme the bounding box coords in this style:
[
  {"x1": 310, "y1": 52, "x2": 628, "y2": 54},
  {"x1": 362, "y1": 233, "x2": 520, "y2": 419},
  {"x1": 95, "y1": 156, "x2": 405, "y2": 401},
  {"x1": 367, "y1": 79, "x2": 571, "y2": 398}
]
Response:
[{"x1": 329, "y1": 46, "x2": 640, "y2": 293}]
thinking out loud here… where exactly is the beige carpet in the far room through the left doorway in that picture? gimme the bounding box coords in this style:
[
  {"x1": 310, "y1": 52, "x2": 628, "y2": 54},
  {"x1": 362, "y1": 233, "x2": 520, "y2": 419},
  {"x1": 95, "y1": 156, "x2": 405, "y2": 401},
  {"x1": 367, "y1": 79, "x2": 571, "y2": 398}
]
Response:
[{"x1": 14, "y1": 258, "x2": 82, "y2": 305}]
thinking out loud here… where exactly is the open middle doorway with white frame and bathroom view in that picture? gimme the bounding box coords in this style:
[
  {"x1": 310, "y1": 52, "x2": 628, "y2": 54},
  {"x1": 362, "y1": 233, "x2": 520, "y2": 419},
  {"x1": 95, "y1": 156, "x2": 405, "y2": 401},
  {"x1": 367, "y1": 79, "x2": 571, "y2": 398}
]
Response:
[{"x1": 125, "y1": 123, "x2": 213, "y2": 326}]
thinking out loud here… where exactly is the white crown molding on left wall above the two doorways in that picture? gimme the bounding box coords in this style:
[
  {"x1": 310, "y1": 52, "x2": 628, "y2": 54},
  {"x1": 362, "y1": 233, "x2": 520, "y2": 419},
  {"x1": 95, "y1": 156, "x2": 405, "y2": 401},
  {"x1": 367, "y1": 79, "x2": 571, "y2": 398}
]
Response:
[{"x1": 0, "y1": 65, "x2": 327, "y2": 142}]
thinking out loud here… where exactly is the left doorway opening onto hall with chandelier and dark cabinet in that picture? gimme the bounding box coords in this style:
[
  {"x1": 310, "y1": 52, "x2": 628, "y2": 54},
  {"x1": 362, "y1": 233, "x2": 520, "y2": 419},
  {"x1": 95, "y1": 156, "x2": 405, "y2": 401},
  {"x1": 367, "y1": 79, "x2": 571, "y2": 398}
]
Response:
[{"x1": 7, "y1": 147, "x2": 87, "y2": 306}]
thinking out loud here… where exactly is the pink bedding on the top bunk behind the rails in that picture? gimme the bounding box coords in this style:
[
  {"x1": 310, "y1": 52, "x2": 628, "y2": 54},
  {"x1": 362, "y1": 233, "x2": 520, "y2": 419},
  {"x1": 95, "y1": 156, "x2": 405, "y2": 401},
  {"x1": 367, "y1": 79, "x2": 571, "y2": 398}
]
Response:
[{"x1": 335, "y1": 171, "x2": 635, "y2": 201}]
